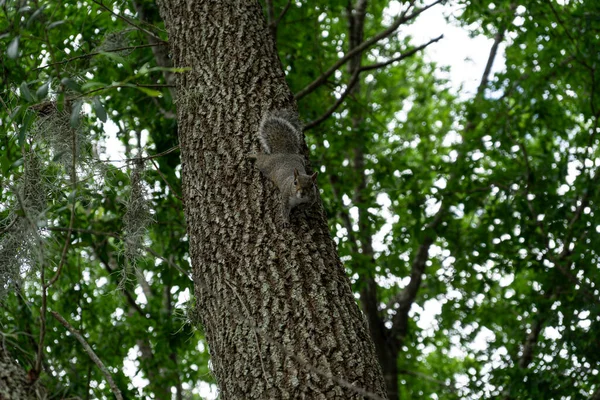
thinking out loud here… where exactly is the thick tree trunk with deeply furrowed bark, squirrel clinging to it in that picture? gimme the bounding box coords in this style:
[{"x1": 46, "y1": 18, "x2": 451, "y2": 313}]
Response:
[{"x1": 160, "y1": 0, "x2": 385, "y2": 399}]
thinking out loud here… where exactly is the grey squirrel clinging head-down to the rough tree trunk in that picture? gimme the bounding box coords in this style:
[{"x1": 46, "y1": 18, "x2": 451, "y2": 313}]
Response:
[{"x1": 248, "y1": 110, "x2": 317, "y2": 225}]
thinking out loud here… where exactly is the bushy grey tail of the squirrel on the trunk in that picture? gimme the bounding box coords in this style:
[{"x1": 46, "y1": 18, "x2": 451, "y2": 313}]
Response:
[{"x1": 259, "y1": 109, "x2": 302, "y2": 154}]
